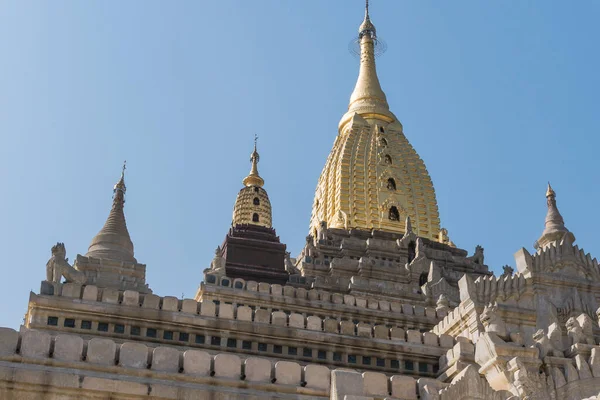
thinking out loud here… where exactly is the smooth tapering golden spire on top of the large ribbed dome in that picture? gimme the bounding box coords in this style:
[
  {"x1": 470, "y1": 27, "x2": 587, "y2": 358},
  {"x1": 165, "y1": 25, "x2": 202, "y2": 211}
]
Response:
[{"x1": 342, "y1": 0, "x2": 396, "y2": 122}]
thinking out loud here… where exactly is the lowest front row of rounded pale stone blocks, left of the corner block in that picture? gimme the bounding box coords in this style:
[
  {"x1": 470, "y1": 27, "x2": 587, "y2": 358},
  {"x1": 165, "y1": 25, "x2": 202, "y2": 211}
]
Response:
[{"x1": 0, "y1": 328, "x2": 330, "y2": 398}]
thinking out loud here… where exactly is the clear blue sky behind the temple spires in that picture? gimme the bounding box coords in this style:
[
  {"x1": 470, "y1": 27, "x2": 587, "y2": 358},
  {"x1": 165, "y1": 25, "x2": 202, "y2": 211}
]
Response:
[{"x1": 0, "y1": 0, "x2": 600, "y2": 328}]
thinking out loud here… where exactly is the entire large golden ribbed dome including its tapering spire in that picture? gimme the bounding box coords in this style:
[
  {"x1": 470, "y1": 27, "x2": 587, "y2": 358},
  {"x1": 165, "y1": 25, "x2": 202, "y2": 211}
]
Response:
[{"x1": 311, "y1": 7, "x2": 440, "y2": 240}]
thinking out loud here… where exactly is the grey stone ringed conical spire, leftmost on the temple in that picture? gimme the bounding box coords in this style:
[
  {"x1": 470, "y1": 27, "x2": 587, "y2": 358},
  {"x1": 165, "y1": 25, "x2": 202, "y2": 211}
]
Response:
[{"x1": 86, "y1": 163, "x2": 137, "y2": 262}]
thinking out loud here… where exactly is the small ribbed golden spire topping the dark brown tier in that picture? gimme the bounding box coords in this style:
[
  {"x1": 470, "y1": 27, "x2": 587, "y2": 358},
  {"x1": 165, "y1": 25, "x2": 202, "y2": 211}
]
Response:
[{"x1": 232, "y1": 138, "x2": 272, "y2": 228}]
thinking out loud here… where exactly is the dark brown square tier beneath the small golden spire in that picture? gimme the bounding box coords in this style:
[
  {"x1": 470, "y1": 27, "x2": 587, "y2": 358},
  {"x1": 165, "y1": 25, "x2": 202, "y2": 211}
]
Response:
[{"x1": 221, "y1": 224, "x2": 288, "y2": 285}]
